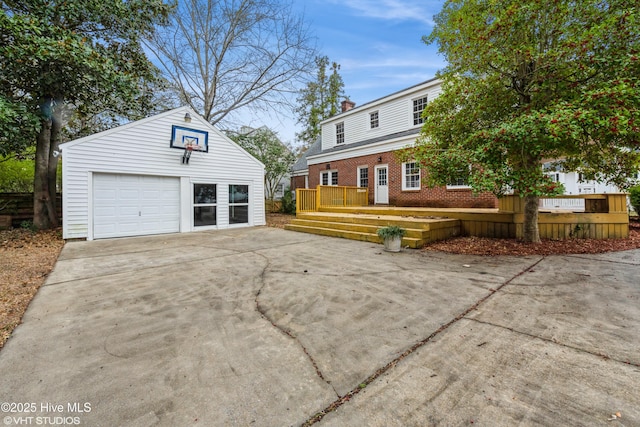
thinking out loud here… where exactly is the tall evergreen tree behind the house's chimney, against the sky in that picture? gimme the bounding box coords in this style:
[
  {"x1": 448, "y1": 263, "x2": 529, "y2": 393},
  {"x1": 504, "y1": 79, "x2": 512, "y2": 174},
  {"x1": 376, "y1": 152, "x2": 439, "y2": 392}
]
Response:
[{"x1": 295, "y1": 56, "x2": 345, "y2": 148}]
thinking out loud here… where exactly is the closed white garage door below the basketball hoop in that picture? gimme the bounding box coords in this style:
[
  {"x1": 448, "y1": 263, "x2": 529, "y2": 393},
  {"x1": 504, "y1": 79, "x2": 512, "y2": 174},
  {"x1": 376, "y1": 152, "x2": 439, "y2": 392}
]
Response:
[{"x1": 93, "y1": 174, "x2": 180, "y2": 239}]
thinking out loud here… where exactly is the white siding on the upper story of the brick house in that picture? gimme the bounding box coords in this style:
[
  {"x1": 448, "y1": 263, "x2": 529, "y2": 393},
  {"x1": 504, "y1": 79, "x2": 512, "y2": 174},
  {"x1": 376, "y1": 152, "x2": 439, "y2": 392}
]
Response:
[{"x1": 322, "y1": 80, "x2": 441, "y2": 150}]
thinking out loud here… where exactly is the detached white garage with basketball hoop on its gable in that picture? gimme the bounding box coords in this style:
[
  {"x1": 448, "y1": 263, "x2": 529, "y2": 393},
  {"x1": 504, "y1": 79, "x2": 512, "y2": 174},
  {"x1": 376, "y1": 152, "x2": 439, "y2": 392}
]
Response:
[{"x1": 61, "y1": 108, "x2": 265, "y2": 240}]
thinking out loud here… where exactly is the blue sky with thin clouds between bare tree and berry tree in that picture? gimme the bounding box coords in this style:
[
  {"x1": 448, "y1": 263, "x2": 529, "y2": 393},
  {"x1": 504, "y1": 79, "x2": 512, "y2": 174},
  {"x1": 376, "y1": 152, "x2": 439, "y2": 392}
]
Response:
[{"x1": 245, "y1": 0, "x2": 445, "y2": 143}]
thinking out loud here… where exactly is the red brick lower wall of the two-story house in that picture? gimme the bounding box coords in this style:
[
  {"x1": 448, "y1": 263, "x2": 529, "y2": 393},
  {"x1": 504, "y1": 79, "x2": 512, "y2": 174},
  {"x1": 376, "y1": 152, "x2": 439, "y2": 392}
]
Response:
[{"x1": 303, "y1": 152, "x2": 498, "y2": 208}]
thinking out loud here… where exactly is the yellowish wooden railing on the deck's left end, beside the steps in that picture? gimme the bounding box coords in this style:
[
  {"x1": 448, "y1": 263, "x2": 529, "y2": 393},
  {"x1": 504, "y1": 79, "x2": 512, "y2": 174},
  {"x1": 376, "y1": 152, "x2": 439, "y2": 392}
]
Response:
[{"x1": 296, "y1": 185, "x2": 369, "y2": 212}]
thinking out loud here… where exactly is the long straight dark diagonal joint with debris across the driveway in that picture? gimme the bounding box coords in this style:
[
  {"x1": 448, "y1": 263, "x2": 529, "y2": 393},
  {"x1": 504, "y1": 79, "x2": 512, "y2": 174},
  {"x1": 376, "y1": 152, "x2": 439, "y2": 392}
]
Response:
[{"x1": 301, "y1": 256, "x2": 546, "y2": 427}]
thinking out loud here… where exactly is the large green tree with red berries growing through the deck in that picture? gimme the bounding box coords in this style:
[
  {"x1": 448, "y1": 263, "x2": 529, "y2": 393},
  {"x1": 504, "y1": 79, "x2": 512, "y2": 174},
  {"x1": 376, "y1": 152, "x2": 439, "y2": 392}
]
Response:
[{"x1": 406, "y1": 0, "x2": 640, "y2": 242}]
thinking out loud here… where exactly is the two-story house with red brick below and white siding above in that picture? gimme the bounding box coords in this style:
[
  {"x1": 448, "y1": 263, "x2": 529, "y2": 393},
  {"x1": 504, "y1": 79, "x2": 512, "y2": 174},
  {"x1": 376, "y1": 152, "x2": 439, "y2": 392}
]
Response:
[{"x1": 292, "y1": 79, "x2": 497, "y2": 208}]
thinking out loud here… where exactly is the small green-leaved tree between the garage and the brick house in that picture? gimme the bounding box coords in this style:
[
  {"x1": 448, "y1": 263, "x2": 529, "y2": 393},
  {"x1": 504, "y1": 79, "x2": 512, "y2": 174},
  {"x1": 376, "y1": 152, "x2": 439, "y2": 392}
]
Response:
[{"x1": 228, "y1": 126, "x2": 296, "y2": 202}]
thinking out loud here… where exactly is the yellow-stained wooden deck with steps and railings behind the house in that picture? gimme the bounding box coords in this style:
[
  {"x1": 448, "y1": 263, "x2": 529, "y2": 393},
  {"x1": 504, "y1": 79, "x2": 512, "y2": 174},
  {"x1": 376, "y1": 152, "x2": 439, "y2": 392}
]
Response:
[{"x1": 285, "y1": 188, "x2": 629, "y2": 248}]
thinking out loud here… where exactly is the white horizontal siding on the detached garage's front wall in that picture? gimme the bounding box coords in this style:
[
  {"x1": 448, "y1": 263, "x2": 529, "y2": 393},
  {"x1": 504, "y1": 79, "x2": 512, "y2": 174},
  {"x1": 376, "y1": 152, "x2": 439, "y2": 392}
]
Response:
[{"x1": 61, "y1": 108, "x2": 265, "y2": 239}]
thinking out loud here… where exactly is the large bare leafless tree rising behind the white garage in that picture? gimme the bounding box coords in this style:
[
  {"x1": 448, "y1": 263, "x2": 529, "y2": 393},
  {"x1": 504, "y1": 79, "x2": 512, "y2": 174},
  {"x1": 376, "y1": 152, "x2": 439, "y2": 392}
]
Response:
[{"x1": 148, "y1": 0, "x2": 315, "y2": 124}]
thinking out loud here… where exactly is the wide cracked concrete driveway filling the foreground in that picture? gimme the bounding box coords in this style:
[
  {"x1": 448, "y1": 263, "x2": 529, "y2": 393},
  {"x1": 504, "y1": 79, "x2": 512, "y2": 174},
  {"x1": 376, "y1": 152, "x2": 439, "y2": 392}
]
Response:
[{"x1": 0, "y1": 227, "x2": 640, "y2": 426}]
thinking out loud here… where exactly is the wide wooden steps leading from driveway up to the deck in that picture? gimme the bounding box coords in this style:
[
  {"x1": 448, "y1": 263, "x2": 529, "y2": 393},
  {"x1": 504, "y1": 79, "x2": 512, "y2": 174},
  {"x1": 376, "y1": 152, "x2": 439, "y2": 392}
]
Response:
[{"x1": 285, "y1": 212, "x2": 461, "y2": 248}]
